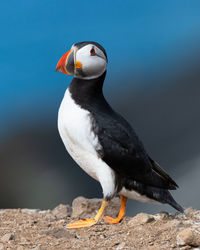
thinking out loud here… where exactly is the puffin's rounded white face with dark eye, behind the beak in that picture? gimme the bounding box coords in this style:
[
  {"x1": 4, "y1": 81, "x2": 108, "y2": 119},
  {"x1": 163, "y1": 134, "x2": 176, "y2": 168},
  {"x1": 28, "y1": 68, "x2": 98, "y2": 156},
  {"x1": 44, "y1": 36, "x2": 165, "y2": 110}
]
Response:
[{"x1": 72, "y1": 44, "x2": 107, "y2": 79}]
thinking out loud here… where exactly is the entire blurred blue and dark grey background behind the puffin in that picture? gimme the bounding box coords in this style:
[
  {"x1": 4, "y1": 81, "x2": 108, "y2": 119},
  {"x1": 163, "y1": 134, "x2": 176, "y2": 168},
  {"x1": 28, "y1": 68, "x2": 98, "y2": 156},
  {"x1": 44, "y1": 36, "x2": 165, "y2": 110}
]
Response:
[{"x1": 0, "y1": 0, "x2": 200, "y2": 215}]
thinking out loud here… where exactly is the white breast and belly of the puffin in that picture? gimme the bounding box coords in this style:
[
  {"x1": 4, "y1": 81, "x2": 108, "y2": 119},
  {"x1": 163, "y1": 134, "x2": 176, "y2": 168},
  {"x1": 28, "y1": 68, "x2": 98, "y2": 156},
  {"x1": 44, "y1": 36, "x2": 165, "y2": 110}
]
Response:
[{"x1": 58, "y1": 89, "x2": 115, "y2": 198}]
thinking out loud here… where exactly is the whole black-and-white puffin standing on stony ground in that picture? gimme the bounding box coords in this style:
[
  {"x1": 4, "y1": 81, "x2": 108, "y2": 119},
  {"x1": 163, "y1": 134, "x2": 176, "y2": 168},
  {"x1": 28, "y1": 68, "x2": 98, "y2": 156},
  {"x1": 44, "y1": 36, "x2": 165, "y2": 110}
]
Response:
[{"x1": 56, "y1": 41, "x2": 184, "y2": 229}]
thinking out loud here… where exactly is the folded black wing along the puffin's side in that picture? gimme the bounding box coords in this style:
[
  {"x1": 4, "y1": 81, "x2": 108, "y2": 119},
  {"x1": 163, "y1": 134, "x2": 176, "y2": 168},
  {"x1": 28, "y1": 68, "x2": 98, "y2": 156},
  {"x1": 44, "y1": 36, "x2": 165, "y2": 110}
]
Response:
[{"x1": 95, "y1": 112, "x2": 178, "y2": 189}]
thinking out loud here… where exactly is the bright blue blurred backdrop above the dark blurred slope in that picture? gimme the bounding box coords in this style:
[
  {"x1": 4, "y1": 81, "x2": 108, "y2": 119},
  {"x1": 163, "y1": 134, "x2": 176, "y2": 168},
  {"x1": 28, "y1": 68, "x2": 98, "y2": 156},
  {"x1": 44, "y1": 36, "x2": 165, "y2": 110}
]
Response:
[{"x1": 0, "y1": 0, "x2": 200, "y2": 137}]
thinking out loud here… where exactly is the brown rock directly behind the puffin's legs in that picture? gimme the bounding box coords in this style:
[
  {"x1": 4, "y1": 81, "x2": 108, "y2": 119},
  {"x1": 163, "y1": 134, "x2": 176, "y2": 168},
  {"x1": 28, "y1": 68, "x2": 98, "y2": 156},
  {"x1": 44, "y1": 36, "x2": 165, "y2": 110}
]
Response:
[{"x1": 71, "y1": 197, "x2": 121, "y2": 218}]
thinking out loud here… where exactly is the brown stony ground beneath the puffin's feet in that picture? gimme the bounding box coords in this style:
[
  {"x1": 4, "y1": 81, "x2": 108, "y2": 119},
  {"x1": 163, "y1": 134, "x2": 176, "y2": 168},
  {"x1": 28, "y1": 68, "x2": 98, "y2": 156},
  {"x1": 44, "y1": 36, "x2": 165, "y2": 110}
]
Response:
[{"x1": 0, "y1": 197, "x2": 200, "y2": 250}]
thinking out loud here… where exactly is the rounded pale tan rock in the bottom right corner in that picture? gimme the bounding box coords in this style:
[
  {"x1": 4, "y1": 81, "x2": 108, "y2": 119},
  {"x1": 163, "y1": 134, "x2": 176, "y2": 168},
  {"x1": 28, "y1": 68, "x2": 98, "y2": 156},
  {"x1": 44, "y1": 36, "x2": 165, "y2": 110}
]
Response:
[{"x1": 176, "y1": 228, "x2": 200, "y2": 247}]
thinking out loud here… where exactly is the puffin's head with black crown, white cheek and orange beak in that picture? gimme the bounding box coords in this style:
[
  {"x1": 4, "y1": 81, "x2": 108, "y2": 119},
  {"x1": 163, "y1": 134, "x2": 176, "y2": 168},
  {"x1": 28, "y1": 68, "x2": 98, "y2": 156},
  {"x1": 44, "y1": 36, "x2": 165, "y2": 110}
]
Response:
[{"x1": 56, "y1": 42, "x2": 107, "y2": 79}]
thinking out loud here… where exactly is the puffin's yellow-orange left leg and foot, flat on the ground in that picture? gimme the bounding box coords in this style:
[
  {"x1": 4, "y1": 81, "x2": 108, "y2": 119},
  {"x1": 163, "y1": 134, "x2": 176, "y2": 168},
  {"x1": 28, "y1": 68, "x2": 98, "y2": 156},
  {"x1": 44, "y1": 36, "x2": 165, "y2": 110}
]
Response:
[{"x1": 67, "y1": 200, "x2": 109, "y2": 228}]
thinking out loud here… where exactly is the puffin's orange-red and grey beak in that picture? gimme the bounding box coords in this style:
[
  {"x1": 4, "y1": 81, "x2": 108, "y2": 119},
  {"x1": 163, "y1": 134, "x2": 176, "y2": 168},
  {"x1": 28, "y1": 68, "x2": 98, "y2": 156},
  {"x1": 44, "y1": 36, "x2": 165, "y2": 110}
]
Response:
[{"x1": 56, "y1": 49, "x2": 75, "y2": 75}]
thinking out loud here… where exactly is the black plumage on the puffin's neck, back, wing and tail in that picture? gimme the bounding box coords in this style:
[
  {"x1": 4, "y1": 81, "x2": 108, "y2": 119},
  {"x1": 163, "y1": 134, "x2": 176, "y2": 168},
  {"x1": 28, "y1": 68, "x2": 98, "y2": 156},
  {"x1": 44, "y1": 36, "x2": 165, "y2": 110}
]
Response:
[{"x1": 69, "y1": 71, "x2": 183, "y2": 212}]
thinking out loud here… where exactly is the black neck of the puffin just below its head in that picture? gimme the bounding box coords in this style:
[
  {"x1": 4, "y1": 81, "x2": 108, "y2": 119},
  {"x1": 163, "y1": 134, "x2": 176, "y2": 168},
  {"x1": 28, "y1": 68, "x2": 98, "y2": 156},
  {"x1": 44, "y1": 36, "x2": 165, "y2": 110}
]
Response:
[{"x1": 69, "y1": 72, "x2": 106, "y2": 107}]
